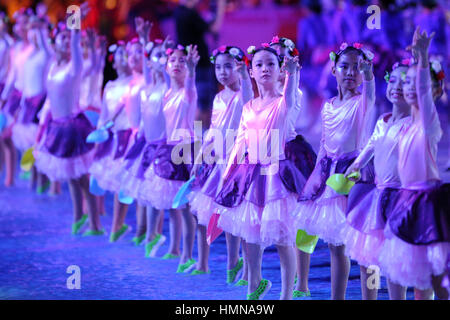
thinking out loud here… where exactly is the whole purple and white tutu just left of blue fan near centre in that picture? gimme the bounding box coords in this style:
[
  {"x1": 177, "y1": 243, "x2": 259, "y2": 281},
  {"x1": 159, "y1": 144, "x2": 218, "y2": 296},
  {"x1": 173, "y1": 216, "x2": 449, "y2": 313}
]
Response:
[{"x1": 140, "y1": 142, "x2": 196, "y2": 210}]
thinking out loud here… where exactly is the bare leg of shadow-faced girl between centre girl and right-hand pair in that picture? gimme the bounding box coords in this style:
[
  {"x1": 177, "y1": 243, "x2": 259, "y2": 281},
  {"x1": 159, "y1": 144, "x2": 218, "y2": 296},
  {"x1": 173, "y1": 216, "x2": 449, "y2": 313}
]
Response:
[{"x1": 328, "y1": 244, "x2": 350, "y2": 300}]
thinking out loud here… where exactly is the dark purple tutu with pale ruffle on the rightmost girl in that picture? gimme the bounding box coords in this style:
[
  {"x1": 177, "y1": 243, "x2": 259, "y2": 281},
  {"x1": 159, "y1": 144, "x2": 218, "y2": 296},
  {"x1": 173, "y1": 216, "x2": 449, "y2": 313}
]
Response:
[{"x1": 379, "y1": 184, "x2": 450, "y2": 290}]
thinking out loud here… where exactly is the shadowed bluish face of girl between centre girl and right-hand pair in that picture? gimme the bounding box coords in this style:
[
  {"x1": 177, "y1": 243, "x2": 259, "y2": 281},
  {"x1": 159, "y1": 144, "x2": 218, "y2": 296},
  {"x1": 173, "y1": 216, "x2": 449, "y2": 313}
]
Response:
[{"x1": 332, "y1": 52, "x2": 362, "y2": 90}]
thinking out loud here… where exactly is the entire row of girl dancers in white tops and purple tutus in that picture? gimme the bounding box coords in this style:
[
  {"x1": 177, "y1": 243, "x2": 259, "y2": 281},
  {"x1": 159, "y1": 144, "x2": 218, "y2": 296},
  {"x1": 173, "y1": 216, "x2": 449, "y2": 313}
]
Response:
[{"x1": 0, "y1": 5, "x2": 450, "y2": 300}]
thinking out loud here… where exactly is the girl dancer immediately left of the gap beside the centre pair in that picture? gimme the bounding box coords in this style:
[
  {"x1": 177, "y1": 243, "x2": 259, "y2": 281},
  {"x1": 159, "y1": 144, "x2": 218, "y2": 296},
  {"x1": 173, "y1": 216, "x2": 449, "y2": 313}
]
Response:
[{"x1": 144, "y1": 45, "x2": 199, "y2": 273}]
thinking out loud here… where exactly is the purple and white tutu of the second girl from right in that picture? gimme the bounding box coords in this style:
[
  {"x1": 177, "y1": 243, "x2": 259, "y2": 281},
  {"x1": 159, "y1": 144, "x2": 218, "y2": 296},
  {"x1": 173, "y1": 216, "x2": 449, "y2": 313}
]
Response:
[{"x1": 342, "y1": 183, "x2": 398, "y2": 267}]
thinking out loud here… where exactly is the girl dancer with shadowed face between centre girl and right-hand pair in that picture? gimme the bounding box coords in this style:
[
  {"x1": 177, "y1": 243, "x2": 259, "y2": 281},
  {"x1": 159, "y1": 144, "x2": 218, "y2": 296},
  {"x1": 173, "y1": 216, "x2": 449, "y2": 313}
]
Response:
[{"x1": 297, "y1": 43, "x2": 375, "y2": 299}]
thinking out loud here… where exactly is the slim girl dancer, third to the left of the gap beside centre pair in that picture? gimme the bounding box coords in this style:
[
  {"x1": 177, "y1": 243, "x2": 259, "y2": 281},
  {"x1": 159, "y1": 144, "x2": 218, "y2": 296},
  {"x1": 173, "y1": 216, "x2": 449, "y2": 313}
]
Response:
[{"x1": 90, "y1": 38, "x2": 144, "y2": 242}]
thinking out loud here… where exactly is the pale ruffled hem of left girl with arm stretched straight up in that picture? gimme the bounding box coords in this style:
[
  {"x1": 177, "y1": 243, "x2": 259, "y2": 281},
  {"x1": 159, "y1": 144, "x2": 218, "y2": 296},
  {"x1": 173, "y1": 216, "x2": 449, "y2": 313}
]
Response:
[{"x1": 33, "y1": 150, "x2": 94, "y2": 181}]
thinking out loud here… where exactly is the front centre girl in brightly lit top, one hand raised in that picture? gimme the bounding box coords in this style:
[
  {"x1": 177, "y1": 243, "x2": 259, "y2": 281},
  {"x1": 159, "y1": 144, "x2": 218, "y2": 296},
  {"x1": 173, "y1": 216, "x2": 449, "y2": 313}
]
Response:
[{"x1": 215, "y1": 44, "x2": 306, "y2": 300}]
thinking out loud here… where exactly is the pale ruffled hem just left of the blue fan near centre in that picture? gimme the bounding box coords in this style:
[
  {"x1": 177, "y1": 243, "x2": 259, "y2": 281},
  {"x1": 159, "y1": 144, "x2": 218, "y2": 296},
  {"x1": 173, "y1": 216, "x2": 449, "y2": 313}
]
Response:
[{"x1": 140, "y1": 163, "x2": 185, "y2": 210}]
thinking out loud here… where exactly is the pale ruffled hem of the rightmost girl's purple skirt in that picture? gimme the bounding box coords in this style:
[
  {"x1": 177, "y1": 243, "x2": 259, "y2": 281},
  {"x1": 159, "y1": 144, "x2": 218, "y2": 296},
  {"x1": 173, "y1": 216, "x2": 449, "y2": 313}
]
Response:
[{"x1": 379, "y1": 225, "x2": 450, "y2": 290}]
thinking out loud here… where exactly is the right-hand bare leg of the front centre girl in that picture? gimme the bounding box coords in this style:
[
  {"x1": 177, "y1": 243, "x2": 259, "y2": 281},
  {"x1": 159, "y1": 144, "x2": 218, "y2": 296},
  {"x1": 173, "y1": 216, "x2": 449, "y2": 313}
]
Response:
[{"x1": 277, "y1": 246, "x2": 296, "y2": 300}]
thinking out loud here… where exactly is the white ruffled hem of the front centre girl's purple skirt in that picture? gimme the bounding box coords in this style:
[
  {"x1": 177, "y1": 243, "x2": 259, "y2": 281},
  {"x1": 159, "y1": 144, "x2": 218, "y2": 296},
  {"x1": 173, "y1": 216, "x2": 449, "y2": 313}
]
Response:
[{"x1": 218, "y1": 194, "x2": 297, "y2": 246}]
